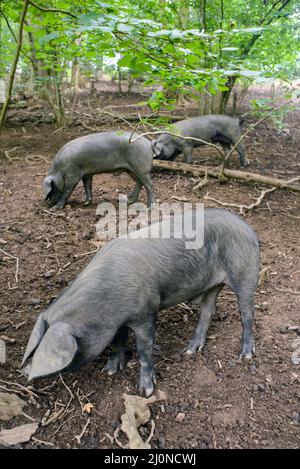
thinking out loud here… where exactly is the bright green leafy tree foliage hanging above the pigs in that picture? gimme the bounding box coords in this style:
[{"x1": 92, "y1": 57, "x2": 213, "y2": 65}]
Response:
[{"x1": 0, "y1": 0, "x2": 300, "y2": 110}]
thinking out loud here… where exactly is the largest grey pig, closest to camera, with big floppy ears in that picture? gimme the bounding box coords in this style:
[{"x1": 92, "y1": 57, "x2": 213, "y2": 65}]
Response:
[{"x1": 22, "y1": 209, "x2": 259, "y2": 396}]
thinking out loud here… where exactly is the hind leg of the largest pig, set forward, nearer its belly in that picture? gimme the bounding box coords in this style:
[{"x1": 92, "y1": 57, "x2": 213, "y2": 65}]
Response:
[{"x1": 185, "y1": 284, "x2": 224, "y2": 355}]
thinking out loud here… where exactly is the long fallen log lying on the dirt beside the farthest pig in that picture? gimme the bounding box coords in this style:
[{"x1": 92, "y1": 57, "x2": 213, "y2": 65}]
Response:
[{"x1": 153, "y1": 160, "x2": 300, "y2": 192}]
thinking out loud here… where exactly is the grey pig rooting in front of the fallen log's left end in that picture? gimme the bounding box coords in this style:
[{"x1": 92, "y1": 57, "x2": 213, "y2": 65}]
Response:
[{"x1": 44, "y1": 131, "x2": 153, "y2": 208}]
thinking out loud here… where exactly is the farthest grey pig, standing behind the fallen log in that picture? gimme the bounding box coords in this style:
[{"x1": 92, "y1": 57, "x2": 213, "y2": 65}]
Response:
[{"x1": 152, "y1": 114, "x2": 245, "y2": 166}]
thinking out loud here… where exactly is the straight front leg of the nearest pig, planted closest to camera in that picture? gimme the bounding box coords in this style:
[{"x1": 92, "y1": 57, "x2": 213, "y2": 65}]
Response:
[{"x1": 132, "y1": 318, "x2": 156, "y2": 397}]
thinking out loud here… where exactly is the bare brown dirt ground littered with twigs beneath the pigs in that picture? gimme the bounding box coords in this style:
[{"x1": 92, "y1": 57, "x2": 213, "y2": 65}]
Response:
[{"x1": 0, "y1": 86, "x2": 300, "y2": 448}]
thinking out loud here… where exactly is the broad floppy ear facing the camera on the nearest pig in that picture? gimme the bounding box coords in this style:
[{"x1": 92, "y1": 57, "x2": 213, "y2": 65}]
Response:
[{"x1": 28, "y1": 323, "x2": 78, "y2": 381}]
